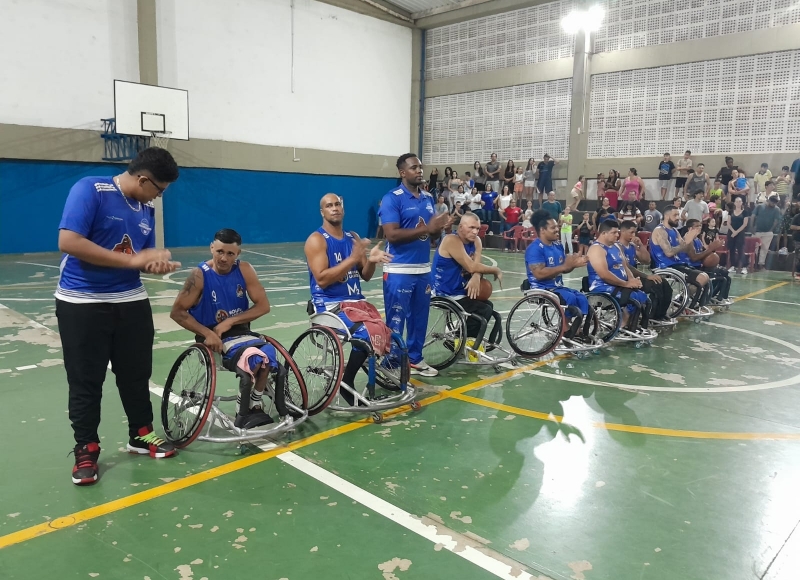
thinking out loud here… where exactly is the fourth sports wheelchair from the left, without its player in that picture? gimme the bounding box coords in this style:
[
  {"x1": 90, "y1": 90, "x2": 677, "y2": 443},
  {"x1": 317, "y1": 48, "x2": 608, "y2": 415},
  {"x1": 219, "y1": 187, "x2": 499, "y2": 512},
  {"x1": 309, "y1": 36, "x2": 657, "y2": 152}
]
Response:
[{"x1": 506, "y1": 280, "x2": 608, "y2": 358}]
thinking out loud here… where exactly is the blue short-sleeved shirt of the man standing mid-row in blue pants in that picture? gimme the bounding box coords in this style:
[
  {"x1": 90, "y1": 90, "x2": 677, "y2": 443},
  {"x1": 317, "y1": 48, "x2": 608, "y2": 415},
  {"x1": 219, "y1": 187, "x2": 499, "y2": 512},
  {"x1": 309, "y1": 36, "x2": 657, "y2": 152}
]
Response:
[{"x1": 379, "y1": 183, "x2": 434, "y2": 274}]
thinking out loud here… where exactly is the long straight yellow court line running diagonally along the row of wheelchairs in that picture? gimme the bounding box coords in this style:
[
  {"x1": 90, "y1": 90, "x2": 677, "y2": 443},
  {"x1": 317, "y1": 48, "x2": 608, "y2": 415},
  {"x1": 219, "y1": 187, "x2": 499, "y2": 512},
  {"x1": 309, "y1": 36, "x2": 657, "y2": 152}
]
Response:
[{"x1": 0, "y1": 355, "x2": 564, "y2": 550}]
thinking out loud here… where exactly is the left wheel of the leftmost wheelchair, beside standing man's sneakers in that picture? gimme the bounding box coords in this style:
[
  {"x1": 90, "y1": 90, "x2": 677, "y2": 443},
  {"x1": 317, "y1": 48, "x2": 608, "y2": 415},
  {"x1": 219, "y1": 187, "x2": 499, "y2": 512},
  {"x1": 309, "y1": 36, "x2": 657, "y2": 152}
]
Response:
[{"x1": 161, "y1": 343, "x2": 217, "y2": 447}]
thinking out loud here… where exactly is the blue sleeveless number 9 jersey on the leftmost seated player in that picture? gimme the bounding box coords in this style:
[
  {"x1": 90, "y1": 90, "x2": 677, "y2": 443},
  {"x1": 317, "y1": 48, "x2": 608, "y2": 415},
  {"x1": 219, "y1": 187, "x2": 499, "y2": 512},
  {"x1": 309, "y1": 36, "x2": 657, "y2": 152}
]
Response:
[{"x1": 189, "y1": 260, "x2": 250, "y2": 328}]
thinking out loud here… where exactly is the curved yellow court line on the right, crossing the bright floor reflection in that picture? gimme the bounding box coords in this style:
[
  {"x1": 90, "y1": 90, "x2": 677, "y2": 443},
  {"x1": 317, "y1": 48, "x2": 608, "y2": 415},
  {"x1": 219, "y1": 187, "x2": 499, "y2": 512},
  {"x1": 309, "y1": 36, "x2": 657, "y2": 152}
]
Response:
[{"x1": 453, "y1": 394, "x2": 800, "y2": 441}]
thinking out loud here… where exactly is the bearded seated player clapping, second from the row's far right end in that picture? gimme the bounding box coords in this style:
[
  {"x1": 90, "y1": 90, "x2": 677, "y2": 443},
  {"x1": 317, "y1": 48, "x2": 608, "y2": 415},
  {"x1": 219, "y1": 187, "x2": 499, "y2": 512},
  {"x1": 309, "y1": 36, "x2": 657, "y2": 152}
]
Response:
[{"x1": 650, "y1": 205, "x2": 709, "y2": 310}]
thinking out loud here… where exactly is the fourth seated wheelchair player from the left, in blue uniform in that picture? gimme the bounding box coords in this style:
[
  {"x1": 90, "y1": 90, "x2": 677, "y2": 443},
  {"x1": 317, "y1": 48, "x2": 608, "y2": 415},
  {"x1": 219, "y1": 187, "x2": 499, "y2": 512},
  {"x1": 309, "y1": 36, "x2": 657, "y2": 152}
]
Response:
[{"x1": 522, "y1": 209, "x2": 590, "y2": 339}]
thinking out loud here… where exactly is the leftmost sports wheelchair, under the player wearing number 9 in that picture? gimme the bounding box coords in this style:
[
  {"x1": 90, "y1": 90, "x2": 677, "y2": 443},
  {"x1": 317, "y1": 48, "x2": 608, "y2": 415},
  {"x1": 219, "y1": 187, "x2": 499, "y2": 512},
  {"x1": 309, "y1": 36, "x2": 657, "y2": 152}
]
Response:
[{"x1": 161, "y1": 335, "x2": 308, "y2": 448}]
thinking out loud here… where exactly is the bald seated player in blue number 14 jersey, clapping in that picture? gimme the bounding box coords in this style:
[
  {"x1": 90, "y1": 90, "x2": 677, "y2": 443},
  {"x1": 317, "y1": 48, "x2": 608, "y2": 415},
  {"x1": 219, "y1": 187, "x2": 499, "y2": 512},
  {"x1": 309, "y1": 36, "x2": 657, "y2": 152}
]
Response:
[{"x1": 305, "y1": 193, "x2": 392, "y2": 405}]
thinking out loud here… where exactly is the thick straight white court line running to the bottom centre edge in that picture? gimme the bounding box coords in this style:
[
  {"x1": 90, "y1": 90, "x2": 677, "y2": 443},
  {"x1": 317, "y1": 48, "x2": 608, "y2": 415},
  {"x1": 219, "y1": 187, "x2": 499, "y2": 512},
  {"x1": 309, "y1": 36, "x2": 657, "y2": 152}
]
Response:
[{"x1": 278, "y1": 454, "x2": 552, "y2": 580}]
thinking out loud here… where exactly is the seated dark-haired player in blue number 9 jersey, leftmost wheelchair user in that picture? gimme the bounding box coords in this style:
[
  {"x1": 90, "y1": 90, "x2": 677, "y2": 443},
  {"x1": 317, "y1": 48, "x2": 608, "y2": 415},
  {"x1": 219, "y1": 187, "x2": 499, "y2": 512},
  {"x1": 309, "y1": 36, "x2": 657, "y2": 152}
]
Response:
[{"x1": 170, "y1": 229, "x2": 283, "y2": 429}]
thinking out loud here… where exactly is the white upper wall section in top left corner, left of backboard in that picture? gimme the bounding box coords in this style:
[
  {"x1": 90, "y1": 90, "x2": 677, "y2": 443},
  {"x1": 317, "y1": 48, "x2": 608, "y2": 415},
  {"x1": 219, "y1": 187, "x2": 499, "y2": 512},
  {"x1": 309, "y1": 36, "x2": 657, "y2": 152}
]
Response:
[{"x1": 0, "y1": 0, "x2": 139, "y2": 129}]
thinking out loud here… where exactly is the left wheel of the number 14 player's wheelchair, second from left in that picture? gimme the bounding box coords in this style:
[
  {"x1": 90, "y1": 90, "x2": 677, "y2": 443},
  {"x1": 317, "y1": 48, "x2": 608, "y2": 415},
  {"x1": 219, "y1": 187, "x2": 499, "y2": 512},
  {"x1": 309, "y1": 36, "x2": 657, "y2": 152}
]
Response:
[{"x1": 289, "y1": 326, "x2": 344, "y2": 415}]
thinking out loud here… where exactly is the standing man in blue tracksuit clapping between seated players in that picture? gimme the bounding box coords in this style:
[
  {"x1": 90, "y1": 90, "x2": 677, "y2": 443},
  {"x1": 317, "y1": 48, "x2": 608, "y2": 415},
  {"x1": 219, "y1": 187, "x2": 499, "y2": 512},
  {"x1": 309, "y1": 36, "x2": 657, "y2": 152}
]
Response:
[{"x1": 380, "y1": 153, "x2": 452, "y2": 377}]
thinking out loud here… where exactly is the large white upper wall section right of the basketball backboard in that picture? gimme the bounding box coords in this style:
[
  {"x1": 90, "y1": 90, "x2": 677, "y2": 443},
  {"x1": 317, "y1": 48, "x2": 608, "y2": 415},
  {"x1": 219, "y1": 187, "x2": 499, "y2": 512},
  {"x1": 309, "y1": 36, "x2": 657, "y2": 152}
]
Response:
[{"x1": 157, "y1": 0, "x2": 411, "y2": 155}]
